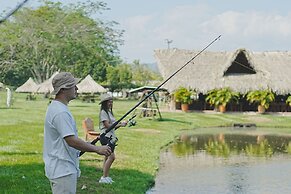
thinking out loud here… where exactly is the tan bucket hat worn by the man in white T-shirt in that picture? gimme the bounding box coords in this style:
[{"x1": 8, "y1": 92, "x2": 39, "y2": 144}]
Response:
[{"x1": 51, "y1": 72, "x2": 80, "y2": 95}]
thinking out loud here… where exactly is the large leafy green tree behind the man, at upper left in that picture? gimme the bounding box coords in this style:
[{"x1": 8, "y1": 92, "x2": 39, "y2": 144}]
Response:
[{"x1": 0, "y1": 1, "x2": 123, "y2": 85}]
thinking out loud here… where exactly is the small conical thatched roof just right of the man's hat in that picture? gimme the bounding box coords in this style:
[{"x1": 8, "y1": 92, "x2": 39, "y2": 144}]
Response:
[{"x1": 77, "y1": 75, "x2": 107, "y2": 94}]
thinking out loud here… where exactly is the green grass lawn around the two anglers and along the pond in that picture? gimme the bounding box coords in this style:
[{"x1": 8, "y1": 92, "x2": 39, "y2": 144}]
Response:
[{"x1": 0, "y1": 91, "x2": 291, "y2": 194}]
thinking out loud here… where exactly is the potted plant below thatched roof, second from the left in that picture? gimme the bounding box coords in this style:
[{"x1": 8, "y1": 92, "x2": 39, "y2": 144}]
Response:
[{"x1": 205, "y1": 88, "x2": 239, "y2": 113}]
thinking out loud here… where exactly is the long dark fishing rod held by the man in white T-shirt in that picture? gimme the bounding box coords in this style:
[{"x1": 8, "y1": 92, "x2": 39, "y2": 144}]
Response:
[{"x1": 79, "y1": 35, "x2": 221, "y2": 156}]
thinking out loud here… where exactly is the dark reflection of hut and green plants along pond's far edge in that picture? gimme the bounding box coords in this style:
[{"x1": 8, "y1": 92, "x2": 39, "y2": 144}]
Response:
[{"x1": 170, "y1": 134, "x2": 291, "y2": 157}]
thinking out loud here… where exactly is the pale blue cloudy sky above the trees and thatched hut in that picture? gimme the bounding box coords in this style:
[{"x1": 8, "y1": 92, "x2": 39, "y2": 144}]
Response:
[{"x1": 0, "y1": 0, "x2": 291, "y2": 63}]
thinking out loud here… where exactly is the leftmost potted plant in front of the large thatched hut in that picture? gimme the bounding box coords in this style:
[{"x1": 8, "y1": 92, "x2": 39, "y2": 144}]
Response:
[{"x1": 174, "y1": 87, "x2": 193, "y2": 112}]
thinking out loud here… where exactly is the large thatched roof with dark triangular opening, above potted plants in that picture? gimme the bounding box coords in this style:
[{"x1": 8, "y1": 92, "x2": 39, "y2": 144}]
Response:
[{"x1": 155, "y1": 49, "x2": 291, "y2": 94}]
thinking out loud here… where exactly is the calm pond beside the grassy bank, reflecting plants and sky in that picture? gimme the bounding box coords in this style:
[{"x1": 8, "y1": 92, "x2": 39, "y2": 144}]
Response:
[{"x1": 147, "y1": 131, "x2": 291, "y2": 194}]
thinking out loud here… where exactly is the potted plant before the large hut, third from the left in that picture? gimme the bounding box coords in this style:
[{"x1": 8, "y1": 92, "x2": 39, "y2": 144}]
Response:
[{"x1": 247, "y1": 89, "x2": 275, "y2": 113}]
